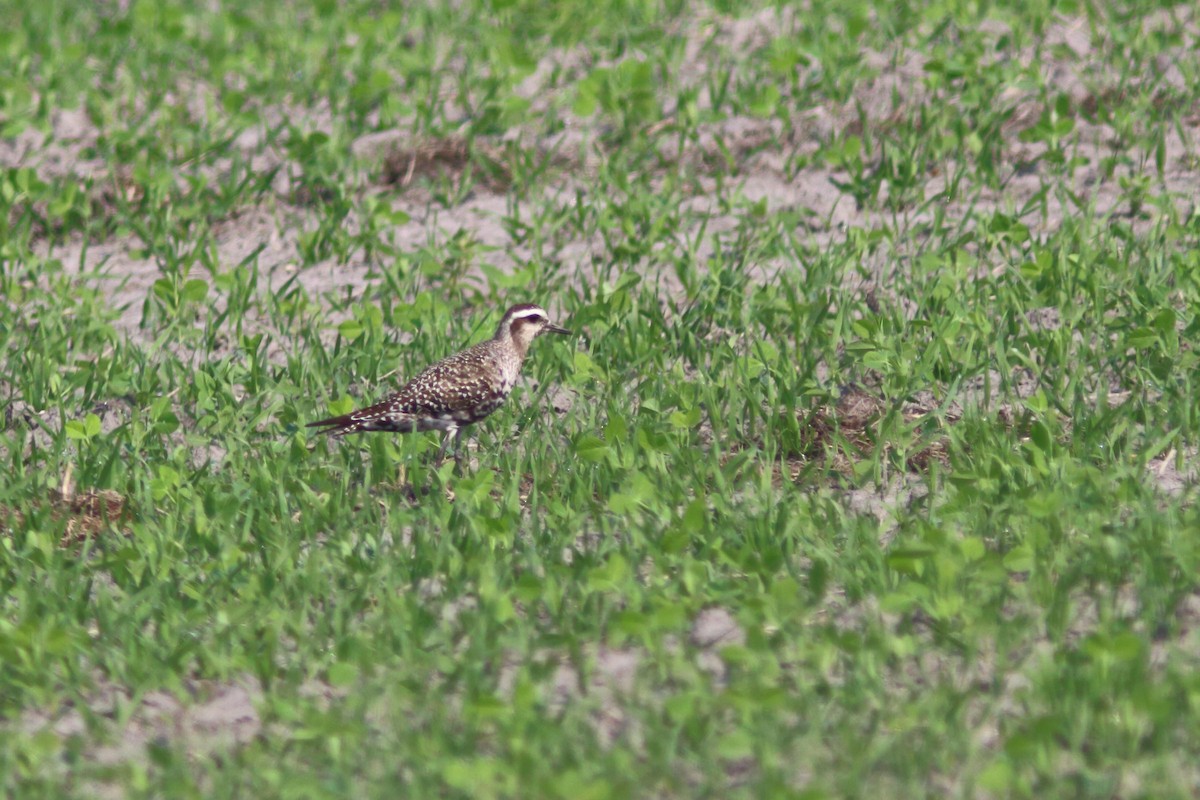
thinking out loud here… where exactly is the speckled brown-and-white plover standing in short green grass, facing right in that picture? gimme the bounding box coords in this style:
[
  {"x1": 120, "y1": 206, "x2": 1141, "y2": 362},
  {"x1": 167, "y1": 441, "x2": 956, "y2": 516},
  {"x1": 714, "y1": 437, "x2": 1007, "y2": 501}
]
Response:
[{"x1": 306, "y1": 303, "x2": 572, "y2": 464}]
